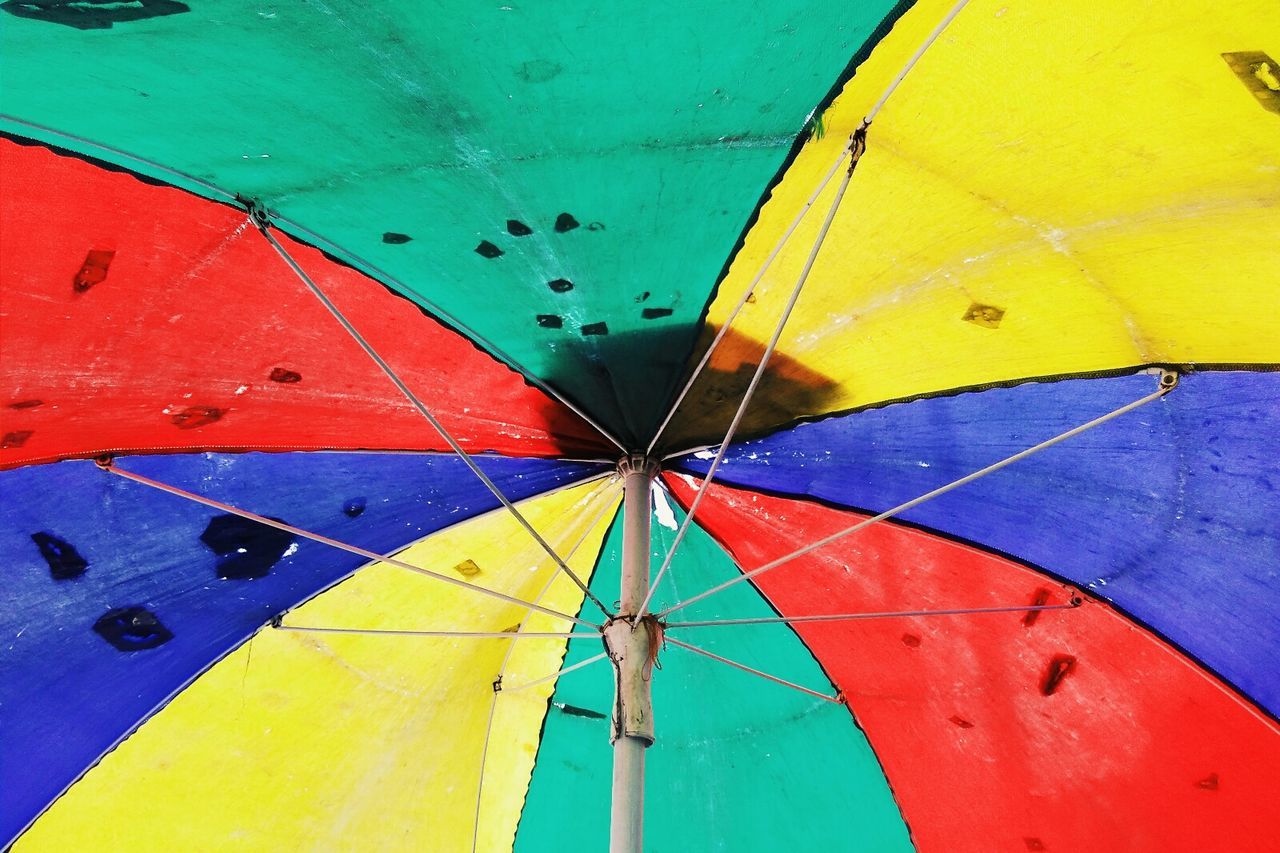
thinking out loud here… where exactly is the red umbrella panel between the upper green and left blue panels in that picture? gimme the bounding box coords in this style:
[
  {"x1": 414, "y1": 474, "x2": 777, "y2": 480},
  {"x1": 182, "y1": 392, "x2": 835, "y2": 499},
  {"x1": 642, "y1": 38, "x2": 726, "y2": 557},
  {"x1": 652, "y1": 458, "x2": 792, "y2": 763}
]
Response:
[{"x1": 0, "y1": 138, "x2": 603, "y2": 467}]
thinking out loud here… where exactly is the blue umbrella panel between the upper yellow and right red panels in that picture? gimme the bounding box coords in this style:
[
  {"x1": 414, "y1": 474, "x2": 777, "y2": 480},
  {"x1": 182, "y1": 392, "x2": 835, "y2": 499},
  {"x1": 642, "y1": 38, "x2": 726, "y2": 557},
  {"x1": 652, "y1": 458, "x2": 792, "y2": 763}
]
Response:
[{"x1": 678, "y1": 371, "x2": 1280, "y2": 715}]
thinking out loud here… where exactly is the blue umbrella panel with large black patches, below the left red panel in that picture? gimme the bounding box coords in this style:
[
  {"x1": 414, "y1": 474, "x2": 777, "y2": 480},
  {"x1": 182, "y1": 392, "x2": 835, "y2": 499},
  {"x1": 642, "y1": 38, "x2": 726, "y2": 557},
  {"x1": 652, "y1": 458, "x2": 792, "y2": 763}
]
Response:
[{"x1": 0, "y1": 453, "x2": 604, "y2": 840}]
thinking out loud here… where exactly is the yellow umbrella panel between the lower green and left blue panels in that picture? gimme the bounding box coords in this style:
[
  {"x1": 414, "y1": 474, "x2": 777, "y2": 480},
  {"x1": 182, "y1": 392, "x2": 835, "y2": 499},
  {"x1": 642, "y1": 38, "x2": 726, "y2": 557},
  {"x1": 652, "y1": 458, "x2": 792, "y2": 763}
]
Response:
[{"x1": 15, "y1": 478, "x2": 620, "y2": 852}]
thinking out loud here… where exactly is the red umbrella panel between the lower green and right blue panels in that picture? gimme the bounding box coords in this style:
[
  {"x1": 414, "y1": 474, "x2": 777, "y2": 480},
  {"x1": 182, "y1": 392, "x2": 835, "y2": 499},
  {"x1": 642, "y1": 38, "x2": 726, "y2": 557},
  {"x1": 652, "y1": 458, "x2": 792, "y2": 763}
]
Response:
[{"x1": 666, "y1": 475, "x2": 1280, "y2": 853}]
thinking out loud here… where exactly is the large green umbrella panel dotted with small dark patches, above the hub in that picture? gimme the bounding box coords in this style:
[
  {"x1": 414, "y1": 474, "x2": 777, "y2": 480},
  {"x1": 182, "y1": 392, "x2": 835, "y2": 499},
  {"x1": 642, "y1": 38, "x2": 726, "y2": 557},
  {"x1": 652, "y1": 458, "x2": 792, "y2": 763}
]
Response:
[{"x1": 0, "y1": 0, "x2": 908, "y2": 443}]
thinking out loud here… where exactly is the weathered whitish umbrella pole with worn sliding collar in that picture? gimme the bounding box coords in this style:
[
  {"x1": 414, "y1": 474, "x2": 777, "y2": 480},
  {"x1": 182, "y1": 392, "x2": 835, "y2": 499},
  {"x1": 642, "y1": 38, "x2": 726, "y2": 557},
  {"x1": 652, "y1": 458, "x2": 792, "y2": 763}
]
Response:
[{"x1": 604, "y1": 455, "x2": 658, "y2": 853}]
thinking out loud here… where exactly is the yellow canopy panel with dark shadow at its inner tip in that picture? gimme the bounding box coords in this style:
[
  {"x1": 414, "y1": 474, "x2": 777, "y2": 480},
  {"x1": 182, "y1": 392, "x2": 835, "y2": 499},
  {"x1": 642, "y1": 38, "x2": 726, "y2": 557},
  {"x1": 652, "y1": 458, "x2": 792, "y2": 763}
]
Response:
[{"x1": 668, "y1": 0, "x2": 1280, "y2": 444}]
